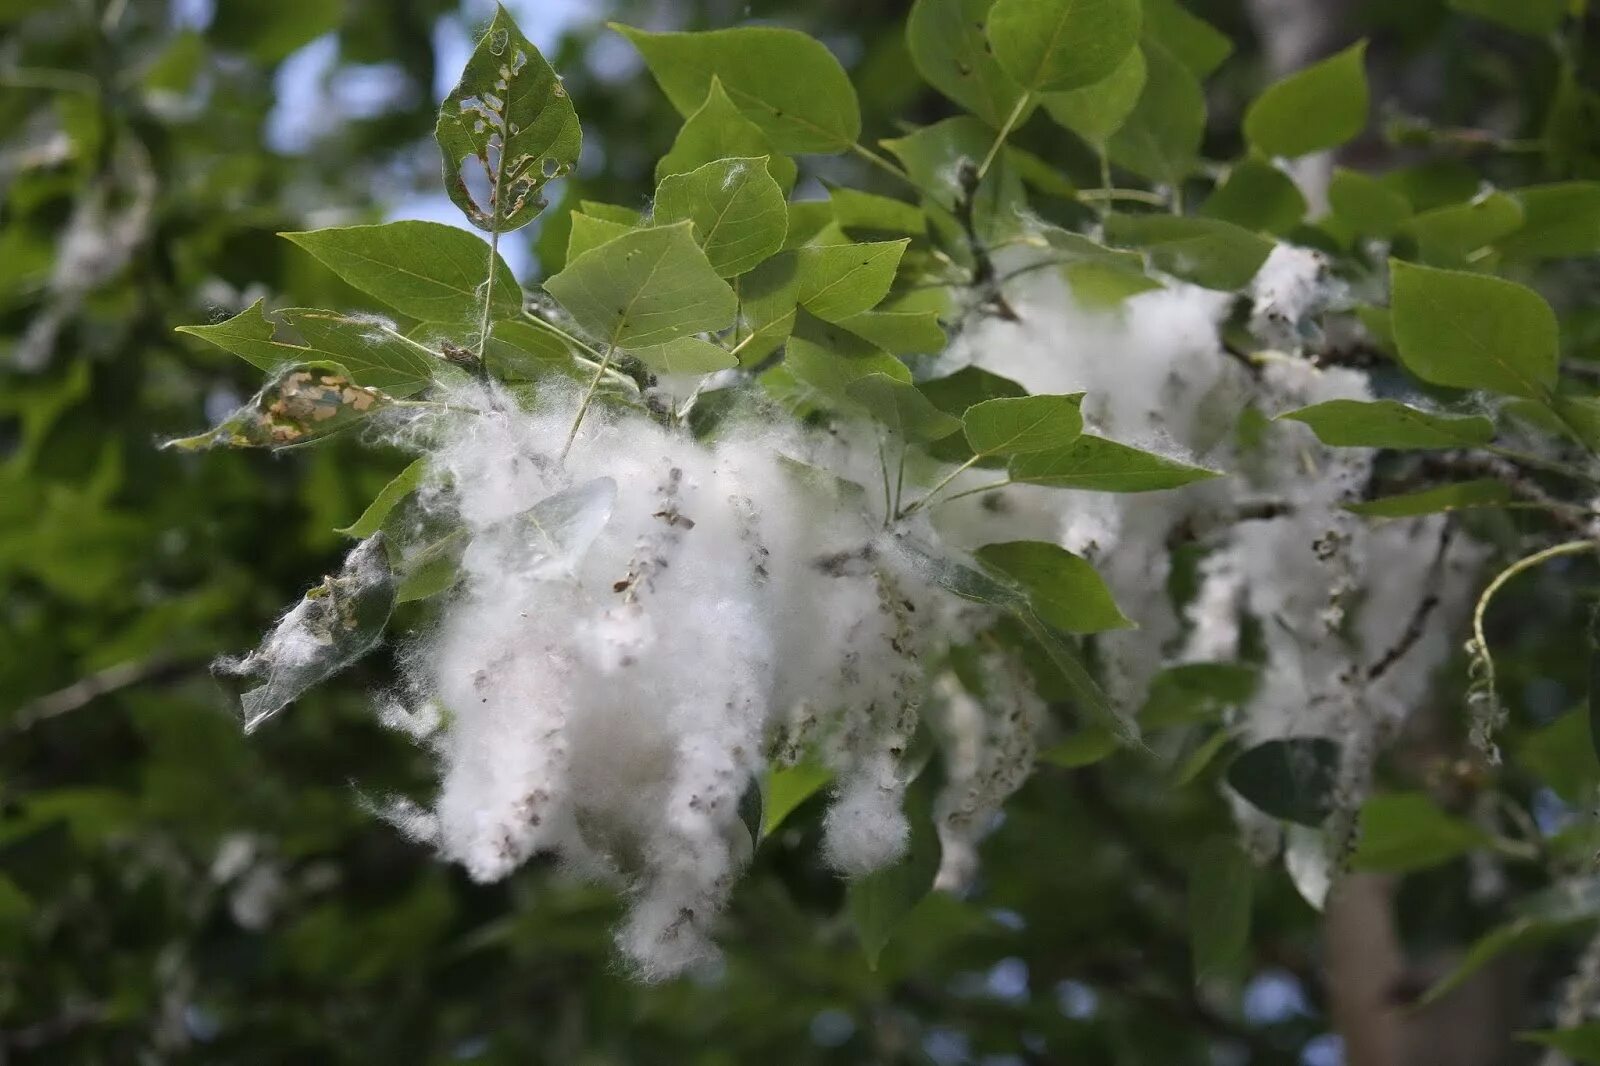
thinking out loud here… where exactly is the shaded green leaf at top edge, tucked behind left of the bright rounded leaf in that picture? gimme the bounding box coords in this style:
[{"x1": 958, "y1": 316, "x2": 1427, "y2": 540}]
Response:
[{"x1": 906, "y1": 0, "x2": 1022, "y2": 128}]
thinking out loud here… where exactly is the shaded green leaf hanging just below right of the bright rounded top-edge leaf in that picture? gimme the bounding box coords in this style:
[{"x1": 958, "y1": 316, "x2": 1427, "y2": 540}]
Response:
[{"x1": 1106, "y1": 40, "x2": 1205, "y2": 186}]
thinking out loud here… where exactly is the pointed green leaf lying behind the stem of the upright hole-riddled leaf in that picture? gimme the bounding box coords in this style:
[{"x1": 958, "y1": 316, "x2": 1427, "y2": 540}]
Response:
[{"x1": 278, "y1": 222, "x2": 522, "y2": 323}]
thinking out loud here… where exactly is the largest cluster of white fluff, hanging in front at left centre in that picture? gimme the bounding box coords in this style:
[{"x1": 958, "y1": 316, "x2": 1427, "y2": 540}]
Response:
[{"x1": 360, "y1": 371, "x2": 1049, "y2": 976}]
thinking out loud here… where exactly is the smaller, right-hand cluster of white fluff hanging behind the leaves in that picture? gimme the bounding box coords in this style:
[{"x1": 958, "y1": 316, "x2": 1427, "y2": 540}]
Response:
[{"x1": 944, "y1": 245, "x2": 1482, "y2": 864}]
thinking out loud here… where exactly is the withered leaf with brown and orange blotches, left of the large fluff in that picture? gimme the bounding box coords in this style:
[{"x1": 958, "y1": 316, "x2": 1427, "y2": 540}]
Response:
[{"x1": 162, "y1": 363, "x2": 392, "y2": 451}]
